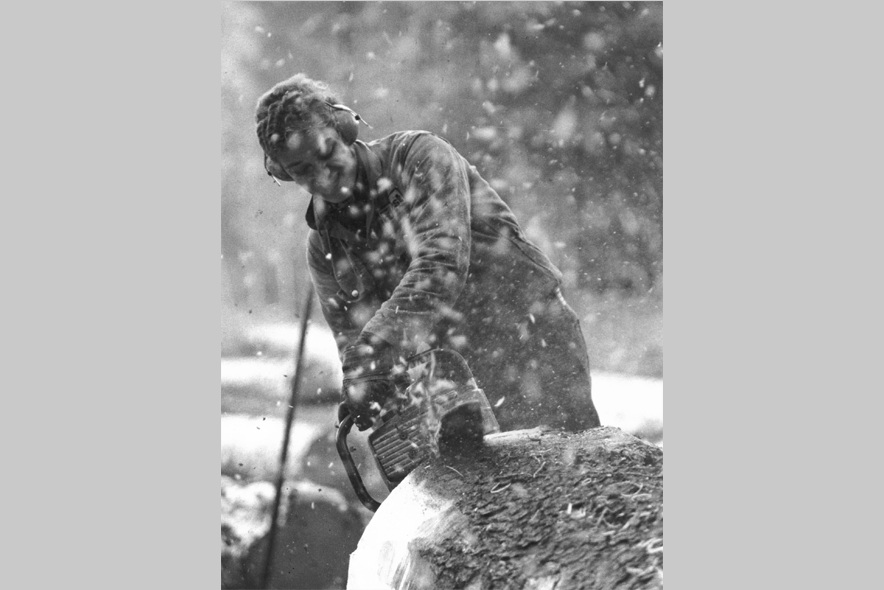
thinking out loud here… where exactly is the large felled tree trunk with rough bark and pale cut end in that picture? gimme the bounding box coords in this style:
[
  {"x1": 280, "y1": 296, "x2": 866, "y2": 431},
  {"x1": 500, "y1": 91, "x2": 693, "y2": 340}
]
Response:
[{"x1": 347, "y1": 427, "x2": 663, "y2": 590}]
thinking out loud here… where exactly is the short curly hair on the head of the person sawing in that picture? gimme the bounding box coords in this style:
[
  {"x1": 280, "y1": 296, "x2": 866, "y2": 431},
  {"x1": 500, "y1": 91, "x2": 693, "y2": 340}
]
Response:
[{"x1": 255, "y1": 74, "x2": 340, "y2": 156}]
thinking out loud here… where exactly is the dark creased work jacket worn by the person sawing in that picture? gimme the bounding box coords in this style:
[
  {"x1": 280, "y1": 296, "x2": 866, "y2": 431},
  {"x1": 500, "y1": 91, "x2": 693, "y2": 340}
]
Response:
[{"x1": 307, "y1": 131, "x2": 561, "y2": 361}]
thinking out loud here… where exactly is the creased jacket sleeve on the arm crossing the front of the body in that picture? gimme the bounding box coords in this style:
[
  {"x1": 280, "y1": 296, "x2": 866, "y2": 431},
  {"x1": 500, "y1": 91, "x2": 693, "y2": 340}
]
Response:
[{"x1": 364, "y1": 133, "x2": 471, "y2": 352}]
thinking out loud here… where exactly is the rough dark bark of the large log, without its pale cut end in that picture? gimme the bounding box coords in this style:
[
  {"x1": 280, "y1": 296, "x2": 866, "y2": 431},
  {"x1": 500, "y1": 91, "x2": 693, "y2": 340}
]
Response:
[{"x1": 414, "y1": 428, "x2": 663, "y2": 590}]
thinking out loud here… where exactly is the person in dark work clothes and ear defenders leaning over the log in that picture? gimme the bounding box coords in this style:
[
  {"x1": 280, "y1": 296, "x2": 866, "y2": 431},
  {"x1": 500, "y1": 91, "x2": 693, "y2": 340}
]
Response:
[{"x1": 256, "y1": 74, "x2": 599, "y2": 431}]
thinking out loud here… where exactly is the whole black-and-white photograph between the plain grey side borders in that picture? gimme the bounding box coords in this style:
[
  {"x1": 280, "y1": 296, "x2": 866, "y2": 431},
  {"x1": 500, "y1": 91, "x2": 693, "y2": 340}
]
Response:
[{"x1": 221, "y1": 1, "x2": 674, "y2": 590}]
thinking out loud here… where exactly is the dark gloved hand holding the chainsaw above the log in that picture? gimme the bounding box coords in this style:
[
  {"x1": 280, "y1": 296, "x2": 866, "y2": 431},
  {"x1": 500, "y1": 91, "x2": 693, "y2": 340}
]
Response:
[{"x1": 343, "y1": 337, "x2": 396, "y2": 430}]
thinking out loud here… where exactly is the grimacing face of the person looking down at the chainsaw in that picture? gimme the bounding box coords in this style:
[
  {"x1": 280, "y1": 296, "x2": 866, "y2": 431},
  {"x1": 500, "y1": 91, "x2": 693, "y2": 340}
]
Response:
[{"x1": 273, "y1": 128, "x2": 356, "y2": 203}]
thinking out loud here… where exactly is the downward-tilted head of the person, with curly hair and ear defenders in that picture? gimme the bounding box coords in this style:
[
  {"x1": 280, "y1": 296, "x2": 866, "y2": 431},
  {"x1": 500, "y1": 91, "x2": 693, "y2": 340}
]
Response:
[{"x1": 255, "y1": 74, "x2": 358, "y2": 203}]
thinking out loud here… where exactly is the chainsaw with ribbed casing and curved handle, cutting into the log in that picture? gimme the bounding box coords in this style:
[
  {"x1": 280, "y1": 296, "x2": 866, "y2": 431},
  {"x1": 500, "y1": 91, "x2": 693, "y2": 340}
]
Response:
[{"x1": 336, "y1": 349, "x2": 500, "y2": 512}]
